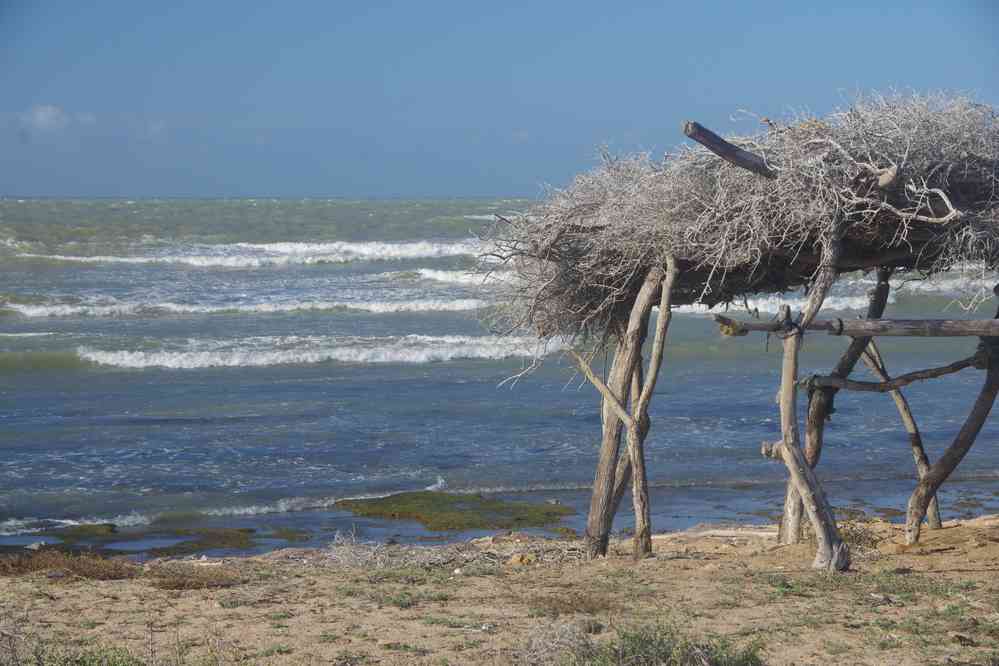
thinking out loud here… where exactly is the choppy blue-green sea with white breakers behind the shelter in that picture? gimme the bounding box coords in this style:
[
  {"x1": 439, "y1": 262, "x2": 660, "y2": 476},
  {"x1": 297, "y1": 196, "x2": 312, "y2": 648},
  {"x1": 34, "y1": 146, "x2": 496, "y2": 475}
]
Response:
[{"x1": 0, "y1": 199, "x2": 999, "y2": 543}]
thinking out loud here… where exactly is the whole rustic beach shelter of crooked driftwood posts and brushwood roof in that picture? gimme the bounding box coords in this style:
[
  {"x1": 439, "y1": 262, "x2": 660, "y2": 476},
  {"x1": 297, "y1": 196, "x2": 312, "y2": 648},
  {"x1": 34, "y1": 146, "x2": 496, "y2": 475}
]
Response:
[{"x1": 490, "y1": 95, "x2": 999, "y2": 570}]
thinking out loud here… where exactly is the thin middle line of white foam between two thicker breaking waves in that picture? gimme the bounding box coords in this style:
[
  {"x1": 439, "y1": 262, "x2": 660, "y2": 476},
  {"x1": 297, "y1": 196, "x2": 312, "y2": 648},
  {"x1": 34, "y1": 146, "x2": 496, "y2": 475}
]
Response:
[{"x1": 3, "y1": 298, "x2": 490, "y2": 317}]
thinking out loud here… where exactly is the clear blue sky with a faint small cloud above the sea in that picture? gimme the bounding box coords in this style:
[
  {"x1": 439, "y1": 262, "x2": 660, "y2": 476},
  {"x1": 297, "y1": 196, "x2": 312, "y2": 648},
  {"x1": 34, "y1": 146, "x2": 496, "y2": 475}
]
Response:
[{"x1": 0, "y1": 0, "x2": 999, "y2": 198}]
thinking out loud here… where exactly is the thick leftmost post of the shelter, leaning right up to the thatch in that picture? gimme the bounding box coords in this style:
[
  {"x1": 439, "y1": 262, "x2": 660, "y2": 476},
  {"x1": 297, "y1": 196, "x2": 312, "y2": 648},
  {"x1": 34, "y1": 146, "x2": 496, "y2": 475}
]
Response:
[{"x1": 585, "y1": 269, "x2": 664, "y2": 557}]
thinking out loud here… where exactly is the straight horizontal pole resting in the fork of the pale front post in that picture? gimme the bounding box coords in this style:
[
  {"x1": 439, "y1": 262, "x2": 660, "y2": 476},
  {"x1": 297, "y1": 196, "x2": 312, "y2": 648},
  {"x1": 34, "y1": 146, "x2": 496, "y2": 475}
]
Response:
[{"x1": 715, "y1": 315, "x2": 999, "y2": 338}]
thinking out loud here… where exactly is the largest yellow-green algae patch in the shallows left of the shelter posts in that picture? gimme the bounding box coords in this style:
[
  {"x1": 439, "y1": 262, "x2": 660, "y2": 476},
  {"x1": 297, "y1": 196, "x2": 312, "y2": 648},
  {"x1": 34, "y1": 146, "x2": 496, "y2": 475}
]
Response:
[{"x1": 336, "y1": 490, "x2": 575, "y2": 531}]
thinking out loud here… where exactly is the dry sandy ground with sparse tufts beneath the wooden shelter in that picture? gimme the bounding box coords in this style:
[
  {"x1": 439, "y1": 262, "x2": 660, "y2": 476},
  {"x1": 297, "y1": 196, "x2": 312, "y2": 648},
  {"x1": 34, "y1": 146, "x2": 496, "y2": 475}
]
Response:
[{"x1": 0, "y1": 516, "x2": 999, "y2": 664}]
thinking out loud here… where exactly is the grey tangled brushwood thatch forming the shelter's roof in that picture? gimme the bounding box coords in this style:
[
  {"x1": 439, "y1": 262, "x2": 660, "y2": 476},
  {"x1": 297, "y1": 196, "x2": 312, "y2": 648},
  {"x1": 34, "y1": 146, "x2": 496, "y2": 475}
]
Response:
[{"x1": 489, "y1": 94, "x2": 999, "y2": 343}]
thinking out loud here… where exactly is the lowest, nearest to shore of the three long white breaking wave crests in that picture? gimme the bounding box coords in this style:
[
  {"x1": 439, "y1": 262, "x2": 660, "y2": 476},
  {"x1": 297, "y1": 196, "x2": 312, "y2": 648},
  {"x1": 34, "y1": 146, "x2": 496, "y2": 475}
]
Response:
[{"x1": 77, "y1": 335, "x2": 553, "y2": 370}]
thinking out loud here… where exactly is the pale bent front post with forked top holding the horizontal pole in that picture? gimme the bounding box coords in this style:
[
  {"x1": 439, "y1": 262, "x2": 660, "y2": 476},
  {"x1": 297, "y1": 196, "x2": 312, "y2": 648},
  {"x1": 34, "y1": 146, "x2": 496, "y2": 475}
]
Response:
[{"x1": 779, "y1": 306, "x2": 850, "y2": 571}]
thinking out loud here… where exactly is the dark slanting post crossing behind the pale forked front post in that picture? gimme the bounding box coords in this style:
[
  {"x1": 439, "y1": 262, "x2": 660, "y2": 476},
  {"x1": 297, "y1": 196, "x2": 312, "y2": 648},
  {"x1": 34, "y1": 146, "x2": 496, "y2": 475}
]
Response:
[{"x1": 775, "y1": 268, "x2": 893, "y2": 543}]
